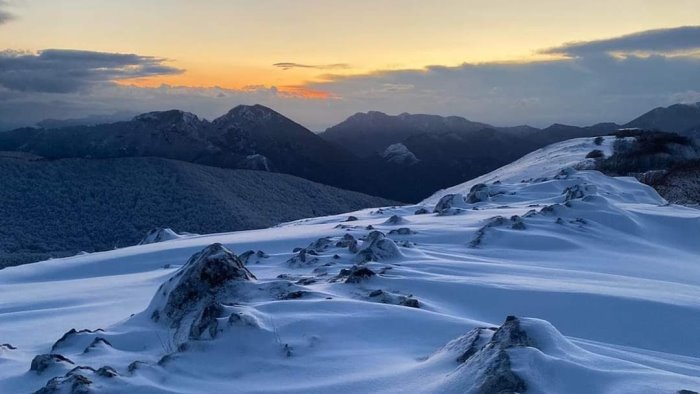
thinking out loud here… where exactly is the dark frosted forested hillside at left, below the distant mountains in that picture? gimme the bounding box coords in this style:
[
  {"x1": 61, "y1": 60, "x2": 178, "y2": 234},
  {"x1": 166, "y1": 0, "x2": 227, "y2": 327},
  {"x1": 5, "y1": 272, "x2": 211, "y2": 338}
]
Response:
[{"x1": 0, "y1": 157, "x2": 391, "y2": 267}]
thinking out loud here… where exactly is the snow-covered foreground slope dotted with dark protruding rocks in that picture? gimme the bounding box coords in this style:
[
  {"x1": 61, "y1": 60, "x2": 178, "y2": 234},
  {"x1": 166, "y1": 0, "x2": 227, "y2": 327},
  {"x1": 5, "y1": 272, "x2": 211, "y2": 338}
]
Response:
[{"x1": 0, "y1": 138, "x2": 700, "y2": 394}]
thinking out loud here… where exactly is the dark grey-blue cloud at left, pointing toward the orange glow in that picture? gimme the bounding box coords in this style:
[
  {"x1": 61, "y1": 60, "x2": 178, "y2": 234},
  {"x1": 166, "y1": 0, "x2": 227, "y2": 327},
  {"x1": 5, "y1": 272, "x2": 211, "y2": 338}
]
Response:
[{"x1": 0, "y1": 49, "x2": 183, "y2": 93}]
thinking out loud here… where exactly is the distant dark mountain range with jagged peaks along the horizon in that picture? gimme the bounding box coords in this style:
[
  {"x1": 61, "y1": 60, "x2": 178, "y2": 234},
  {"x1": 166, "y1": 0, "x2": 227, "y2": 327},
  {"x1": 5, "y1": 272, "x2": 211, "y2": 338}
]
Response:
[{"x1": 0, "y1": 104, "x2": 700, "y2": 202}]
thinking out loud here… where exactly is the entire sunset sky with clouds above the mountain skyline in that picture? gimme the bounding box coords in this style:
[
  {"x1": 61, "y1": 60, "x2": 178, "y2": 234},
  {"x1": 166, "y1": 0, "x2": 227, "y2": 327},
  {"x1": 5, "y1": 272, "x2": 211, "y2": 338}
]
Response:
[{"x1": 0, "y1": 0, "x2": 700, "y2": 131}]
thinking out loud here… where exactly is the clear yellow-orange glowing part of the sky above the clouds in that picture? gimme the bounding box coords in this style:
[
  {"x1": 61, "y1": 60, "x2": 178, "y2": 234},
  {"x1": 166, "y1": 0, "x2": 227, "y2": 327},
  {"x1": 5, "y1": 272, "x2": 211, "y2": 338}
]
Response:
[{"x1": 0, "y1": 0, "x2": 700, "y2": 89}]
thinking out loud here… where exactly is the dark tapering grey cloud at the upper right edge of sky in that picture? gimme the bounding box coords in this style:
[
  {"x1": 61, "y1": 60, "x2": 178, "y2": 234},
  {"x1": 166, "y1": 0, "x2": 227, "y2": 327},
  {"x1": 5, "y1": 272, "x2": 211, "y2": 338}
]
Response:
[{"x1": 541, "y1": 26, "x2": 700, "y2": 56}]
